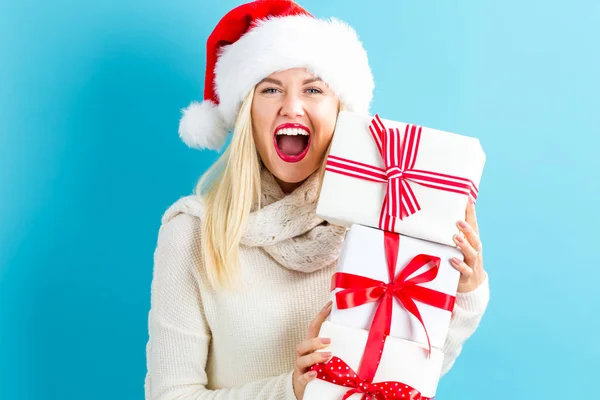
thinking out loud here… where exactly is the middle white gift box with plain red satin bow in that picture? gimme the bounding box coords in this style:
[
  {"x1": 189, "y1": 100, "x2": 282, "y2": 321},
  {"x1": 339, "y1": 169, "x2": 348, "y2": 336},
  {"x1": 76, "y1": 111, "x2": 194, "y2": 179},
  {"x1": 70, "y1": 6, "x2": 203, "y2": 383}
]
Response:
[{"x1": 328, "y1": 225, "x2": 463, "y2": 348}]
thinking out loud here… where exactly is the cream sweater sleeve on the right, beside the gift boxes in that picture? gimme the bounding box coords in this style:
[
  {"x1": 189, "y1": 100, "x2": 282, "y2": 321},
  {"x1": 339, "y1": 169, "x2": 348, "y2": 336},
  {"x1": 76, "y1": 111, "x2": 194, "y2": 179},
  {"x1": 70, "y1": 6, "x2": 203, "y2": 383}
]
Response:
[{"x1": 441, "y1": 276, "x2": 490, "y2": 376}]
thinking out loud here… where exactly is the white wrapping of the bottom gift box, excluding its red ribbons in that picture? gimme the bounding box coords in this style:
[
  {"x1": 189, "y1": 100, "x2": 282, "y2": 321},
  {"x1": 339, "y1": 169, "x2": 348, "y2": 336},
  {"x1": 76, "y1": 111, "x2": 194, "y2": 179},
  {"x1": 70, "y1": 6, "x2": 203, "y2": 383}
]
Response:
[{"x1": 304, "y1": 321, "x2": 444, "y2": 400}]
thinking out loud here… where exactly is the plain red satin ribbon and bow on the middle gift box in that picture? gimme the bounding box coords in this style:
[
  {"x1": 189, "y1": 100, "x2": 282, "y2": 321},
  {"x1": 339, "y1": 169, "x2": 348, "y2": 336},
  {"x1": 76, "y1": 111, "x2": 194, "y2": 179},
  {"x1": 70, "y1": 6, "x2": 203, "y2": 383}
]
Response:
[{"x1": 331, "y1": 231, "x2": 456, "y2": 380}]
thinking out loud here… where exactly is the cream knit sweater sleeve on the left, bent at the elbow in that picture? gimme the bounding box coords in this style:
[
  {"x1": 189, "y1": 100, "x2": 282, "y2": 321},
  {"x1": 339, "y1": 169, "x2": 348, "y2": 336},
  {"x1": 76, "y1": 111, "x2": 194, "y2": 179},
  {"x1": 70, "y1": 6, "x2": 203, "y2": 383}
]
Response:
[{"x1": 144, "y1": 214, "x2": 296, "y2": 400}]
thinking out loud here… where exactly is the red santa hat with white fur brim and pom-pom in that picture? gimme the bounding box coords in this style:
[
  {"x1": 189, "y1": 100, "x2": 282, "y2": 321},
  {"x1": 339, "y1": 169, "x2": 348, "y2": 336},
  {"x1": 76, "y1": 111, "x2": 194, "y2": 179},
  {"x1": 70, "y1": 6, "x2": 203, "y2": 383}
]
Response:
[{"x1": 179, "y1": 0, "x2": 374, "y2": 150}]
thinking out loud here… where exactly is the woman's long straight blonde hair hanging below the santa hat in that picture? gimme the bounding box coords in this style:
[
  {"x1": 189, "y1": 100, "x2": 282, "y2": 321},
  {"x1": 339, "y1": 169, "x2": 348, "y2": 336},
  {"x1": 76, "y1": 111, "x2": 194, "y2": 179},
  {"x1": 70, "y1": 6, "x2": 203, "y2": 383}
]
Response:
[{"x1": 195, "y1": 89, "x2": 344, "y2": 289}]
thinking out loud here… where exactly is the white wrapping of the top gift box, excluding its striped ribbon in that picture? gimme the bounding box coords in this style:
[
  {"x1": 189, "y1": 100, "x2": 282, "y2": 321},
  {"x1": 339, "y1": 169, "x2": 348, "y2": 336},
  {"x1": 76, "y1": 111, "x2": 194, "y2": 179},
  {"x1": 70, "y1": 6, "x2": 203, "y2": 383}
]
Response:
[{"x1": 316, "y1": 111, "x2": 485, "y2": 246}]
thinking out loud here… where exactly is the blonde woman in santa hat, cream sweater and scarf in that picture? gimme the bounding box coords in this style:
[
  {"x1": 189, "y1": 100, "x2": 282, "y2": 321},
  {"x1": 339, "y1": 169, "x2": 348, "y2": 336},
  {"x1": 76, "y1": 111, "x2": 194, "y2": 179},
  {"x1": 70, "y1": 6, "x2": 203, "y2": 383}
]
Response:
[{"x1": 145, "y1": 0, "x2": 489, "y2": 400}]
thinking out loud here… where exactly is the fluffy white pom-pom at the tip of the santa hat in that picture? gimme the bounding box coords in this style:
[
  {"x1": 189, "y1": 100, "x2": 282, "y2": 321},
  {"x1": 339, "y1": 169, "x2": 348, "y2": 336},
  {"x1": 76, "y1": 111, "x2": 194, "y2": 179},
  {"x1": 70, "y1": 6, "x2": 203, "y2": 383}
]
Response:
[{"x1": 179, "y1": 100, "x2": 228, "y2": 151}]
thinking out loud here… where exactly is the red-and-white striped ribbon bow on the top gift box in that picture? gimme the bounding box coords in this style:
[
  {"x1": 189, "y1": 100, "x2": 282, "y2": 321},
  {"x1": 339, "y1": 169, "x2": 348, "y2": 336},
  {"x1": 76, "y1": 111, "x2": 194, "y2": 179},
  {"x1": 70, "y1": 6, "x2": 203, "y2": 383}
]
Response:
[{"x1": 325, "y1": 115, "x2": 477, "y2": 231}]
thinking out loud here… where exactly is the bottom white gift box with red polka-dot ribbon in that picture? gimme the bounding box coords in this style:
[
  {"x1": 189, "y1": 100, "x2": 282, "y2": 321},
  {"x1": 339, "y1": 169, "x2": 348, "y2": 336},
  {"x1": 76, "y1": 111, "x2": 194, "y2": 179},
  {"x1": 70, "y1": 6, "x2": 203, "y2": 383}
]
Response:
[{"x1": 304, "y1": 321, "x2": 444, "y2": 400}]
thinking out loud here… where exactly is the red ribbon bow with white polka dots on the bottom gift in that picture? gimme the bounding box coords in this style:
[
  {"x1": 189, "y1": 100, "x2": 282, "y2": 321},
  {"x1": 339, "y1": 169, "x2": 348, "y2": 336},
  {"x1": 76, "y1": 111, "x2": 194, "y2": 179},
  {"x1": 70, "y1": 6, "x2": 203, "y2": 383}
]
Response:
[{"x1": 311, "y1": 356, "x2": 433, "y2": 400}]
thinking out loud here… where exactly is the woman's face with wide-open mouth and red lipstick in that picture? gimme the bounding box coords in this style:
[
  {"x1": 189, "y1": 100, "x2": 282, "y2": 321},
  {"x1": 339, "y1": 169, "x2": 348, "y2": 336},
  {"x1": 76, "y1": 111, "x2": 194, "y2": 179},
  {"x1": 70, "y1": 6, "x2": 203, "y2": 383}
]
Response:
[{"x1": 251, "y1": 68, "x2": 339, "y2": 192}]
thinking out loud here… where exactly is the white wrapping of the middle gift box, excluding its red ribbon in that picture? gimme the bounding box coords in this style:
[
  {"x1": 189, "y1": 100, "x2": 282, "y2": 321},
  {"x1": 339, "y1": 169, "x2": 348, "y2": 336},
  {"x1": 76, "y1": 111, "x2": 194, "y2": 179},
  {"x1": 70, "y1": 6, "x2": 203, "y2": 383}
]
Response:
[{"x1": 328, "y1": 225, "x2": 464, "y2": 349}]
